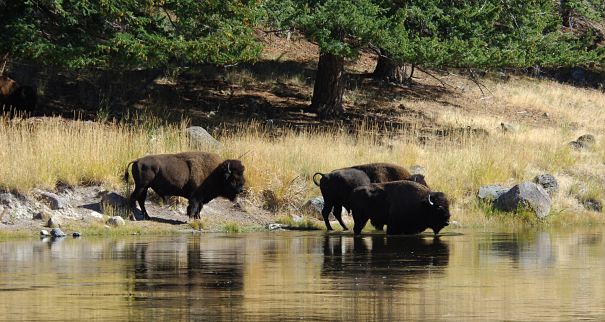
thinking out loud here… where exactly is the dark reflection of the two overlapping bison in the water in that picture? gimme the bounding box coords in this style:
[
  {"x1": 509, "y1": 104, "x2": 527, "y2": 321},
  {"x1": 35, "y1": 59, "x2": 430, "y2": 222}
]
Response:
[{"x1": 322, "y1": 235, "x2": 449, "y2": 289}]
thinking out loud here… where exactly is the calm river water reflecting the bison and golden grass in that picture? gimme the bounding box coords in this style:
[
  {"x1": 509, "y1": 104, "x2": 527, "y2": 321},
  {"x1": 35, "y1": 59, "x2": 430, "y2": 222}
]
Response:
[{"x1": 0, "y1": 227, "x2": 605, "y2": 321}]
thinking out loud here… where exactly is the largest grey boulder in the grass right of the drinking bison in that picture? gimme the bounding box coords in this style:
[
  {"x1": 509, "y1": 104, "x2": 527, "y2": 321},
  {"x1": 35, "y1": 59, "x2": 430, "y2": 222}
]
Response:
[{"x1": 494, "y1": 181, "x2": 551, "y2": 219}]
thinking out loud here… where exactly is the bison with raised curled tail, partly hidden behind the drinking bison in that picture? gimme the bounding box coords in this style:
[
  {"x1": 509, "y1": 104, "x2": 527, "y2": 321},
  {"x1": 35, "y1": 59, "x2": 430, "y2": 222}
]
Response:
[{"x1": 313, "y1": 163, "x2": 426, "y2": 230}]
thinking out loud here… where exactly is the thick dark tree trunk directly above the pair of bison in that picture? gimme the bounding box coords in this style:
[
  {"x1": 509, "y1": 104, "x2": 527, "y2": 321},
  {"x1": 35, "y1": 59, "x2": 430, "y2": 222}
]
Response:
[{"x1": 311, "y1": 53, "x2": 344, "y2": 118}]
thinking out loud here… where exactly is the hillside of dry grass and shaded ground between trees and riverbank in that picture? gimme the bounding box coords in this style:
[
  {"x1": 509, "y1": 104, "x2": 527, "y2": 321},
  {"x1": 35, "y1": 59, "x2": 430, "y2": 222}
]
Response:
[{"x1": 0, "y1": 34, "x2": 605, "y2": 234}]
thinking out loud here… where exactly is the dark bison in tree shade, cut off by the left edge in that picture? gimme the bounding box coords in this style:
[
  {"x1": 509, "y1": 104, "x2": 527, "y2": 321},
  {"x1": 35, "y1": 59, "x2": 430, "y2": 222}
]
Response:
[{"x1": 0, "y1": 75, "x2": 37, "y2": 114}]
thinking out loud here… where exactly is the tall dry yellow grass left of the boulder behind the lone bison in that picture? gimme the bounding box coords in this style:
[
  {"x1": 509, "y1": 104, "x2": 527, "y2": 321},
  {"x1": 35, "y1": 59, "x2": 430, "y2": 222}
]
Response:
[{"x1": 0, "y1": 118, "x2": 187, "y2": 191}]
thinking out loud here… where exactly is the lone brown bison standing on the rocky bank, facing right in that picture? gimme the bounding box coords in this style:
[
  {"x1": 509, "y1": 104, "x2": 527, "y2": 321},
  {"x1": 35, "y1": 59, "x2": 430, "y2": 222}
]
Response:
[{"x1": 124, "y1": 152, "x2": 244, "y2": 219}]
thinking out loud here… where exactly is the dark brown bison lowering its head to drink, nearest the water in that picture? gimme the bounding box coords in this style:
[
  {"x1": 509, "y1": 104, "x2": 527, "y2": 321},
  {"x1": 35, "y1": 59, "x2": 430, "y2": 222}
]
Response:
[{"x1": 350, "y1": 180, "x2": 450, "y2": 234}]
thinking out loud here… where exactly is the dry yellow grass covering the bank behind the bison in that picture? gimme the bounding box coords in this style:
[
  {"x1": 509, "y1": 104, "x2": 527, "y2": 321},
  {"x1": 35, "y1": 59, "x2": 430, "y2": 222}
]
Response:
[{"x1": 0, "y1": 76, "x2": 605, "y2": 226}]
